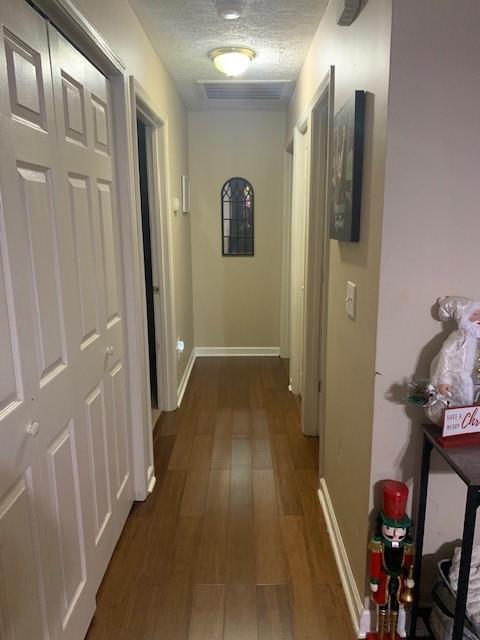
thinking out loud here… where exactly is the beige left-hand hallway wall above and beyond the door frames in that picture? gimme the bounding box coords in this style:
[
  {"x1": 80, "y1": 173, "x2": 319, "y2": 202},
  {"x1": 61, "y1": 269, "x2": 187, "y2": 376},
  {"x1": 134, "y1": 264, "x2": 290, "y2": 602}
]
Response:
[{"x1": 76, "y1": 0, "x2": 193, "y2": 380}]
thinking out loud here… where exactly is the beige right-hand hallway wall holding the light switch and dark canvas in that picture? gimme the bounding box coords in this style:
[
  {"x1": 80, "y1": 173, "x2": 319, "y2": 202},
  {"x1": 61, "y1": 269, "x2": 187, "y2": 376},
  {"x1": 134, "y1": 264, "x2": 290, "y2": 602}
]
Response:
[{"x1": 287, "y1": 0, "x2": 391, "y2": 594}]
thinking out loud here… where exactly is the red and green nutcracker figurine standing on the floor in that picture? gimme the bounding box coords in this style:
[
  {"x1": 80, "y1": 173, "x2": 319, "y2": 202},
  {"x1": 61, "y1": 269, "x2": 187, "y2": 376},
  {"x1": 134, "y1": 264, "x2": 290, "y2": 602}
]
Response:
[{"x1": 367, "y1": 480, "x2": 414, "y2": 640}]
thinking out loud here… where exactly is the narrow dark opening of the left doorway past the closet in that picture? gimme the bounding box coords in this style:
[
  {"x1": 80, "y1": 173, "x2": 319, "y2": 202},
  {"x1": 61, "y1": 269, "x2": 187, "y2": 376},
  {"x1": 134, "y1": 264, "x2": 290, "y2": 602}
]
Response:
[{"x1": 137, "y1": 118, "x2": 158, "y2": 408}]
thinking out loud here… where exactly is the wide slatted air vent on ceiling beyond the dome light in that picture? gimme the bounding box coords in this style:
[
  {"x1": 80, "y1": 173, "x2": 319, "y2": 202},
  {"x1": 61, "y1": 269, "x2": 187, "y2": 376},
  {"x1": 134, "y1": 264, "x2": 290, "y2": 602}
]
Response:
[{"x1": 198, "y1": 80, "x2": 291, "y2": 100}]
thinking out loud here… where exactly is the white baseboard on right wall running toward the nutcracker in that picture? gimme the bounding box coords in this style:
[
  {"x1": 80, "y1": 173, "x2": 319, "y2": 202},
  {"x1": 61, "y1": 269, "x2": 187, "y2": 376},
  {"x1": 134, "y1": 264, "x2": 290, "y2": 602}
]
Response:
[{"x1": 318, "y1": 478, "x2": 407, "y2": 638}]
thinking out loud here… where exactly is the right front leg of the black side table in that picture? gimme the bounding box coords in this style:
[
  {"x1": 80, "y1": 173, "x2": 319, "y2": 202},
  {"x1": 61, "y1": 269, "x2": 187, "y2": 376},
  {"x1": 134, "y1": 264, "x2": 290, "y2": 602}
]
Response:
[{"x1": 452, "y1": 487, "x2": 479, "y2": 640}]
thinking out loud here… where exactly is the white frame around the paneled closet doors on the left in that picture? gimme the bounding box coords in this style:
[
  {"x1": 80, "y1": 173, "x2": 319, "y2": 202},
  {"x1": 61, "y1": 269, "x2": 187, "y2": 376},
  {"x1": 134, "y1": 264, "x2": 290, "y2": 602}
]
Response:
[{"x1": 32, "y1": 0, "x2": 159, "y2": 500}]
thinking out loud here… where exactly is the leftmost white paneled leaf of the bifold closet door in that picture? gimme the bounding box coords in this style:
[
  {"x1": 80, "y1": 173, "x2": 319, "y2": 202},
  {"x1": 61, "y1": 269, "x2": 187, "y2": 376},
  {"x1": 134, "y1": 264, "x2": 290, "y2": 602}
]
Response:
[{"x1": 0, "y1": 0, "x2": 95, "y2": 640}]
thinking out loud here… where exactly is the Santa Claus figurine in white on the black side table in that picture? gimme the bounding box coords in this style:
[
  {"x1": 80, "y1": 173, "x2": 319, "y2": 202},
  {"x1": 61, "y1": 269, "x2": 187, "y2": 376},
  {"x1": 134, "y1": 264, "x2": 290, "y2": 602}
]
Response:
[{"x1": 426, "y1": 296, "x2": 480, "y2": 424}]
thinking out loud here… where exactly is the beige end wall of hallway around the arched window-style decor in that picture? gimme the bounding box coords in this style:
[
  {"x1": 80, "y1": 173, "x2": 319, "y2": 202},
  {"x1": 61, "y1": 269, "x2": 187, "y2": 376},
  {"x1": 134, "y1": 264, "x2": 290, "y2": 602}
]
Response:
[{"x1": 189, "y1": 111, "x2": 285, "y2": 347}]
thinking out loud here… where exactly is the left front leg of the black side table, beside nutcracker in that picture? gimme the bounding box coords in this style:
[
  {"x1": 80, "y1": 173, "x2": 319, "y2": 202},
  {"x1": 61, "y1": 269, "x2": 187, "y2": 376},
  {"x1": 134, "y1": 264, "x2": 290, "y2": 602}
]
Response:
[{"x1": 409, "y1": 435, "x2": 433, "y2": 640}]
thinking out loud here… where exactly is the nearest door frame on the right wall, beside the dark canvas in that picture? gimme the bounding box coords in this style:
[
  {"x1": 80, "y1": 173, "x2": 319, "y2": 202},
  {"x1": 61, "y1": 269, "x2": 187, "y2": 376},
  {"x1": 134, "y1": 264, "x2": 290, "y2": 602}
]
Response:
[{"x1": 301, "y1": 67, "x2": 334, "y2": 451}]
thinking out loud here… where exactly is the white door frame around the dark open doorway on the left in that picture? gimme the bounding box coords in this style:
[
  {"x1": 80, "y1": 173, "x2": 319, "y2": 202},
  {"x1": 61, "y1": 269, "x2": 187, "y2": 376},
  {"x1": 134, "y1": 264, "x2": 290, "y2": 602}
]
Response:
[{"x1": 130, "y1": 76, "x2": 178, "y2": 411}]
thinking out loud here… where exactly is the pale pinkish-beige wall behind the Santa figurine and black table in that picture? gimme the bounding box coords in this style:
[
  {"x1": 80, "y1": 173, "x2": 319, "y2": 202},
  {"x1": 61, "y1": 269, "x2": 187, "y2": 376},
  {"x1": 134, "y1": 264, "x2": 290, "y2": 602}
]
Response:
[{"x1": 372, "y1": 0, "x2": 480, "y2": 600}]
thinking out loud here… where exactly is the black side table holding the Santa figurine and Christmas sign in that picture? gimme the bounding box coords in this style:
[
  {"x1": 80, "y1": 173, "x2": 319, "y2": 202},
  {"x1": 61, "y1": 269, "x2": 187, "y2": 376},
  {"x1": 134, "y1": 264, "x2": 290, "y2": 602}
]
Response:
[{"x1": 409, "y1": 425, "x2": 480, "y2": 640}]
